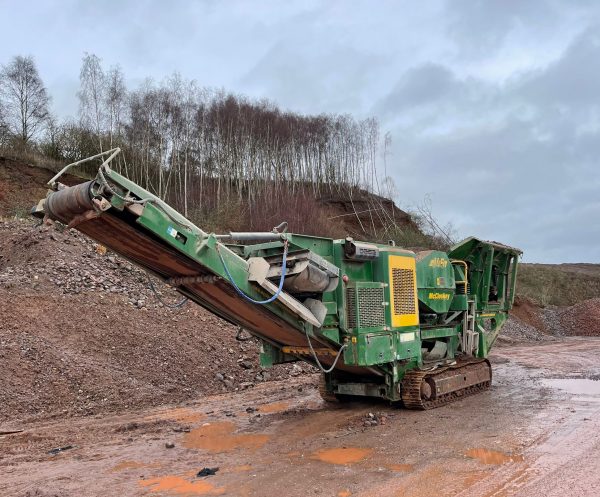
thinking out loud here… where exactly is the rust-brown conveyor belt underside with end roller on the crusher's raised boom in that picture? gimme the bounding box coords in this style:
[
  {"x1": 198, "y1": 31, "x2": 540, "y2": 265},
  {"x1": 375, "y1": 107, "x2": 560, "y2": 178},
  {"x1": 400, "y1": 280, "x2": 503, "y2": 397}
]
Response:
[{"x1": 41, "y1": 183, "x2": 365, "y2": 375}]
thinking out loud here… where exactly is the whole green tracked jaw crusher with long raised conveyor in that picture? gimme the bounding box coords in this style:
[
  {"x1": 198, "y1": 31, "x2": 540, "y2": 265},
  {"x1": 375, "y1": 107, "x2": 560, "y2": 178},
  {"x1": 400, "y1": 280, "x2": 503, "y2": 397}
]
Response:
[{"x1": 33, "y1": 149, "x2": 521, "y2": 409}]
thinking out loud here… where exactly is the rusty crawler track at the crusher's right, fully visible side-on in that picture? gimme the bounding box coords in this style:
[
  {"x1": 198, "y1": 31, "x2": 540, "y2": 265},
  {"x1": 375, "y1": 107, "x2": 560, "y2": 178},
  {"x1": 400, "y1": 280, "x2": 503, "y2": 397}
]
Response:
[{"x1": 402, "y1": 359, "x2": 492, "y2": 410}]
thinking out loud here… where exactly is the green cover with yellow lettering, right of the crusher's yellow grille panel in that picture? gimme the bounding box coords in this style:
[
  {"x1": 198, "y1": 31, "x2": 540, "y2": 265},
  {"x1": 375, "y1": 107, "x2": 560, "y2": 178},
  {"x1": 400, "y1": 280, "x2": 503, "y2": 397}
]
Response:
[{"x1": 417, "y1": 250, "x2": 456, "y2": 314}]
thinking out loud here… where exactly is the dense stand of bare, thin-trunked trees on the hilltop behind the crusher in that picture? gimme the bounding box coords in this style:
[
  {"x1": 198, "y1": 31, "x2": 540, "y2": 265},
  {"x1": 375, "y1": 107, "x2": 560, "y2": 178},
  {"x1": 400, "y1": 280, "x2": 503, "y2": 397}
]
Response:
[{"x1": 39, "y1": 64, "x2": 386, "y2": 235}]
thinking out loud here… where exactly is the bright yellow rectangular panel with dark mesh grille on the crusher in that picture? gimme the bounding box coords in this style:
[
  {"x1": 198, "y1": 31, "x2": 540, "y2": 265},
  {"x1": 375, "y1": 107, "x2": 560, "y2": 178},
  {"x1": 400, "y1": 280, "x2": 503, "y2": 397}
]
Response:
[{"x1": 389, "y1": 255, "x2": 419, "y2": 328}]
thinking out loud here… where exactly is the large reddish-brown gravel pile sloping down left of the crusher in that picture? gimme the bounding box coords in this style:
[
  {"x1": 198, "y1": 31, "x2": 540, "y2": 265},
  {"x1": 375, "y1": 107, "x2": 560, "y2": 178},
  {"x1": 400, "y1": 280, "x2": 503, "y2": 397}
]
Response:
[{"x1": 0, "y1": 220, "x2": 316, "y2": 420}]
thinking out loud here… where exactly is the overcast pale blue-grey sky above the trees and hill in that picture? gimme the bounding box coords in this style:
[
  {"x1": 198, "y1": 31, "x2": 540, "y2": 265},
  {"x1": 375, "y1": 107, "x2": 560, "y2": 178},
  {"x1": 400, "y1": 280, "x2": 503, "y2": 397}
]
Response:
[{"x1": 0, "y1": 0, "x2": 600, "y2": 263}]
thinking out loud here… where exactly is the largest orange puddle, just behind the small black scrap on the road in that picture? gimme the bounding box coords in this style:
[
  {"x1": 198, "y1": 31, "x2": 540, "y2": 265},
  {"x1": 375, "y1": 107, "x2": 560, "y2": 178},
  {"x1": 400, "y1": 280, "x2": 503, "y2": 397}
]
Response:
[{"x1": 183, "y1": 421, "x2": 269, "y2": 452}]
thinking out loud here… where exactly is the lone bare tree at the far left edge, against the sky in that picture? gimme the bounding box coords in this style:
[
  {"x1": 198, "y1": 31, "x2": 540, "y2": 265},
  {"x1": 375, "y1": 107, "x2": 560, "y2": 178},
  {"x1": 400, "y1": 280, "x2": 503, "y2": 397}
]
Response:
[{"x1": 0, "y1": 55, "x2": 50, "y2": 145}]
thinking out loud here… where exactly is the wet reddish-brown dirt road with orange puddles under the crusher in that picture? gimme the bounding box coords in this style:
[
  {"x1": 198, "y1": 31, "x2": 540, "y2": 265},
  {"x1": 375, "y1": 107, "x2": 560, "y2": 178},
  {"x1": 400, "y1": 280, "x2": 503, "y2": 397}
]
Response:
[{"x1": 0, "y1": 338, "x2": 600, "y2": 497}]
